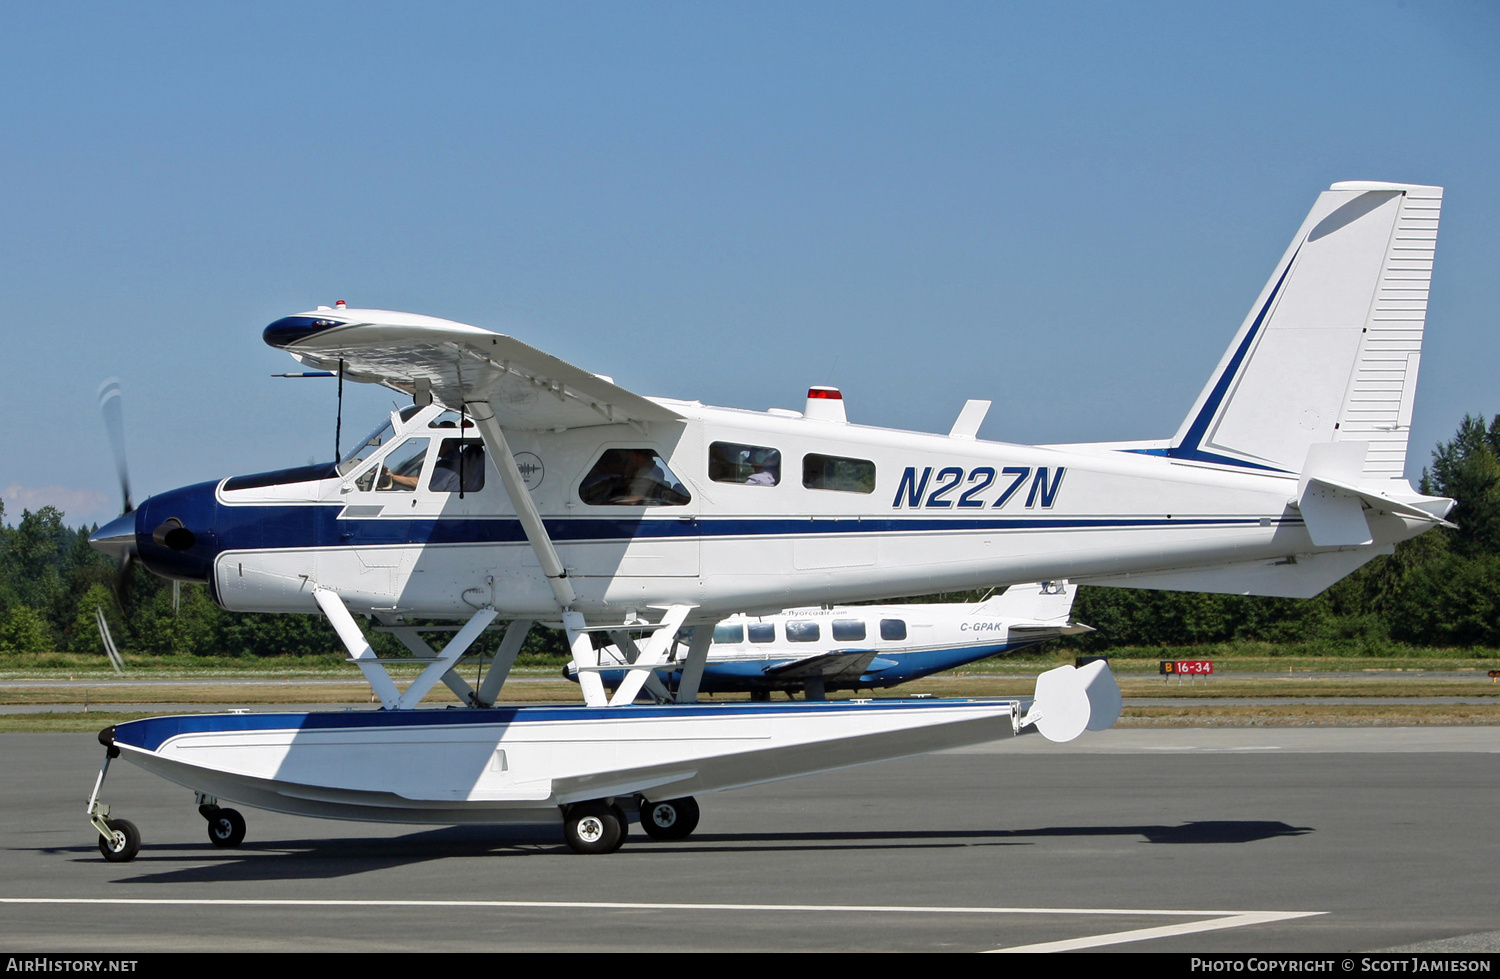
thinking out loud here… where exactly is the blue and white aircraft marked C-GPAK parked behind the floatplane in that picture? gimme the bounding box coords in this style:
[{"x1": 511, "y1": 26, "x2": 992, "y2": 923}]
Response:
[{"x1": 564, "y1": 582, "x2": 1092, "y2": 700}]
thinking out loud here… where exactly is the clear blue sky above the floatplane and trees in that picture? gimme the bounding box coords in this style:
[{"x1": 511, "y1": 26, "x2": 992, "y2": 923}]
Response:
[{"x1": 0, "y1": 0, "x2": 1500, "y2": 523}]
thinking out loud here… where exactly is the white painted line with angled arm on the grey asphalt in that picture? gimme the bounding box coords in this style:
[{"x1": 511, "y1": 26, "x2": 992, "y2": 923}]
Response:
[{"x1": 0, "y1": 898, "x2": 1325, "y2": 952}]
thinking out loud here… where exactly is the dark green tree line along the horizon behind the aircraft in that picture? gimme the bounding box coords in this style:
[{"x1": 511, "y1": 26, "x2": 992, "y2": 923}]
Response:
[{"x1": 0, "y1": 415, "x2": 1500, "y2": 657}]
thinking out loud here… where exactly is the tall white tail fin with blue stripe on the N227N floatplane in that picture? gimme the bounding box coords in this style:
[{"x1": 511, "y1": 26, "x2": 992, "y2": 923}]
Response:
[{"x1": 1158, "y1": 181, "x2": 1443, "y2": 481}]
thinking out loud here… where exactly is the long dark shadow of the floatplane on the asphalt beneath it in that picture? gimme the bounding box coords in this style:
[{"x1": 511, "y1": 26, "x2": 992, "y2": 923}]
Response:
[{"x1": 29, "y1": 820, "x2": 1313, "y2": 883}]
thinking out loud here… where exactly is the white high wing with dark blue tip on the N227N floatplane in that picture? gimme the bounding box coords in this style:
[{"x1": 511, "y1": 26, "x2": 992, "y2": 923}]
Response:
[{"x1": 264, "y1": 307, "x2": 681, "y2": 432}]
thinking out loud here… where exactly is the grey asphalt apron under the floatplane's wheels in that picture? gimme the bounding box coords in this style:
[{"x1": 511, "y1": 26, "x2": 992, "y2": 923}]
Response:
[{"x1": 0, "y1": 727, "x2": 1500, "y2": 952}]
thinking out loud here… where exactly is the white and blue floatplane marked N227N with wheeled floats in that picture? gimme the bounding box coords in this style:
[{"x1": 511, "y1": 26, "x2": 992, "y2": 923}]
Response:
[{"x1": 90, "y1": 181, "x2": 1452, "y2": 859}]
